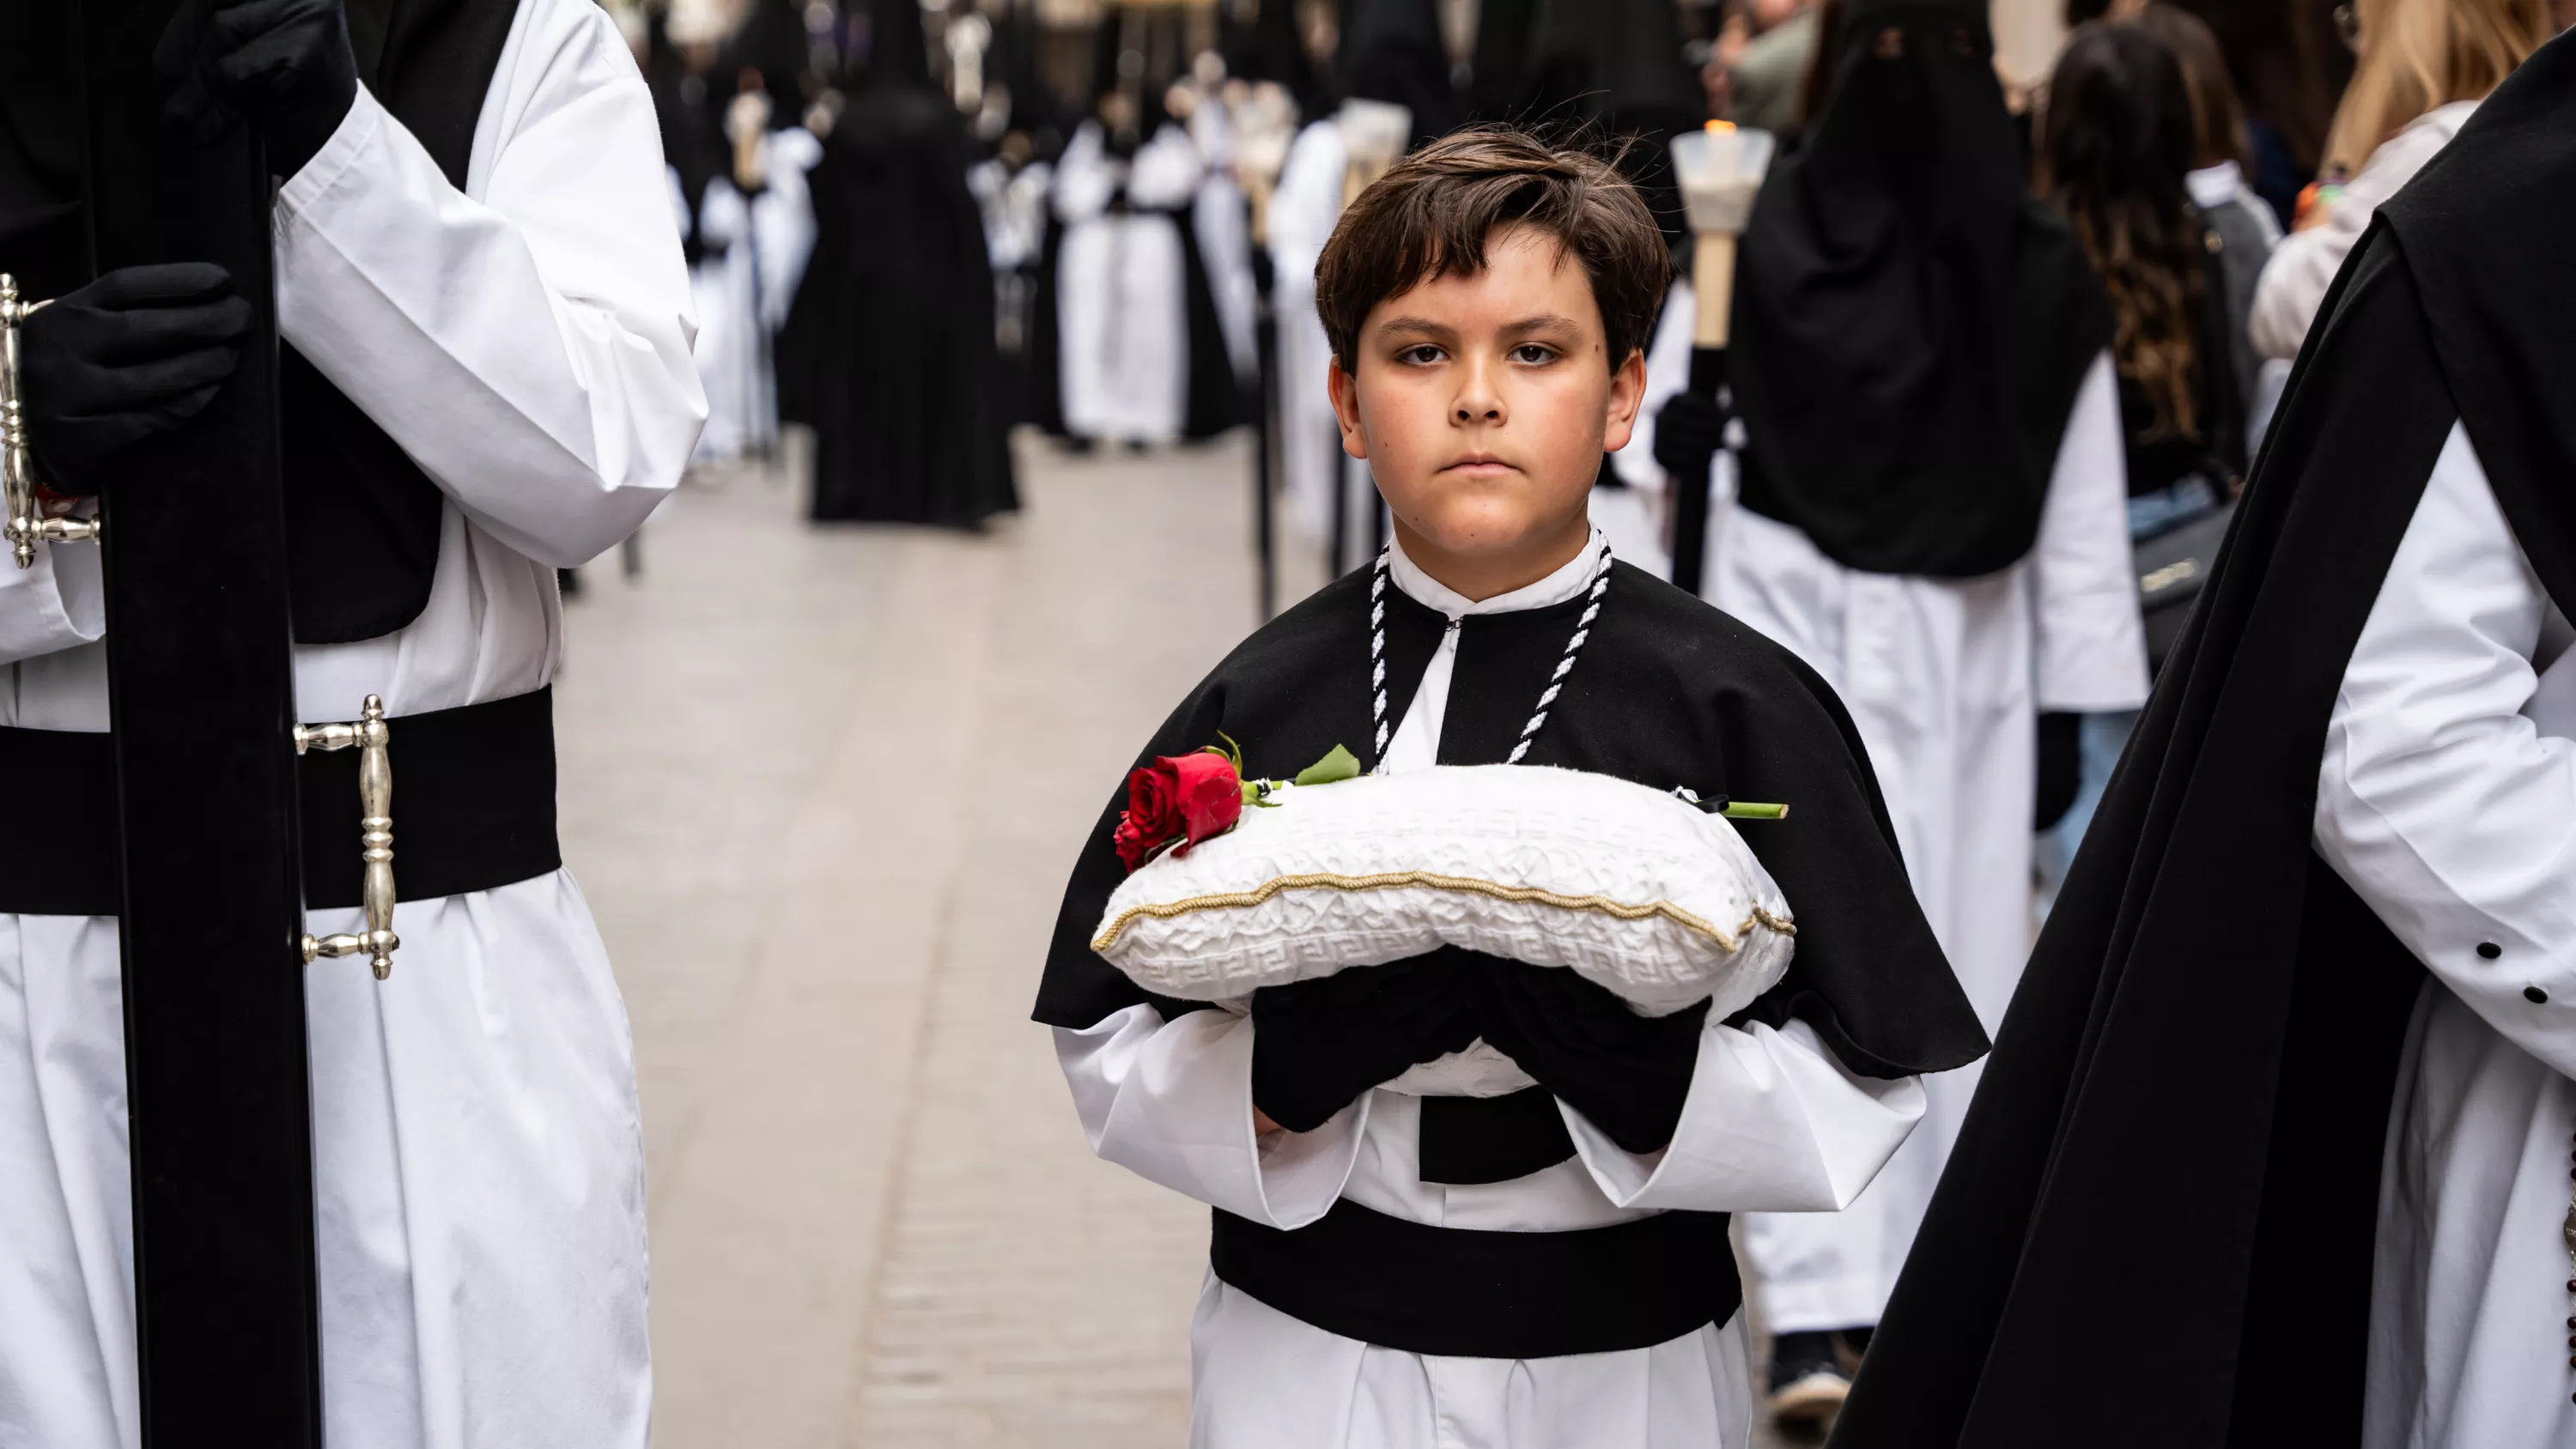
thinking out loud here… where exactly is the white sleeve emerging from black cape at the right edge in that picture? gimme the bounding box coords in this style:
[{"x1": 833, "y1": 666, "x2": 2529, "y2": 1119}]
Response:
[{"x1": 2316, "y1": 427, "x2": 2576, "y2": 1076}]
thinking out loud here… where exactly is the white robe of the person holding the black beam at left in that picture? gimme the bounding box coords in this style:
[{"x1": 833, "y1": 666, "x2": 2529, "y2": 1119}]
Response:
[{"x1": 0, "y1": 0, "x2": 706, "y2": 1449}]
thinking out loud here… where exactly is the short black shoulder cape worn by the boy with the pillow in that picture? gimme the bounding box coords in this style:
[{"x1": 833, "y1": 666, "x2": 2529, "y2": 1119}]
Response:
[{"x1": 1036, "y1": 564, "x2": 1986, "y2": 1078}]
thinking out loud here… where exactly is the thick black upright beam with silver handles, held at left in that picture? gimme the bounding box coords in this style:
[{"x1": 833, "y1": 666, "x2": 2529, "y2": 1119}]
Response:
[{"x1": 77, "y1": 0, "x2": 327, "y2": 1449}]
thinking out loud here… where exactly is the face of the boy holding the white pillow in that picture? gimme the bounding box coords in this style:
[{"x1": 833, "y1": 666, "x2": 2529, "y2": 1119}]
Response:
[{"x1": 1332, "y1": 227, "x2": 1646, "y2": 597}]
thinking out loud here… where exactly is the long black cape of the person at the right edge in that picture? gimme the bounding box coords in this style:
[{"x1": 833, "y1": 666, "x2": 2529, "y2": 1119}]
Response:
[{"x1": 1834, "y1": 27, "x2": 2576, "y2": 1449}]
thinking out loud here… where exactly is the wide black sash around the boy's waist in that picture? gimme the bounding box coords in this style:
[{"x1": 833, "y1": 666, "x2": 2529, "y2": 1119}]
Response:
[{"x1": 1208, "y1": 1199, "x2": 1744, "y2": 1359}]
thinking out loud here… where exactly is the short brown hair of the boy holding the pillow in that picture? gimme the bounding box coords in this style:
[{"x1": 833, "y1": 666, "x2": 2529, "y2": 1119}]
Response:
[{"x1": 1314, "y1": 126, "x2": 1672, "y2": 373}]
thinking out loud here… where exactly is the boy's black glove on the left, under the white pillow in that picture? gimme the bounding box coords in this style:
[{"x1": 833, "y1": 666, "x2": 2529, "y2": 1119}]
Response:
[{"x1": 1252, "y1": 949, "x2": 1476, "y2": 1132}]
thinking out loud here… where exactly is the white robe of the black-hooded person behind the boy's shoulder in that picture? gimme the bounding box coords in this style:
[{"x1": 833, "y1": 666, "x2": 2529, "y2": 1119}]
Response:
[{"x1": 1710, "y1": 353, "x2": 2146, "y2": 1331}]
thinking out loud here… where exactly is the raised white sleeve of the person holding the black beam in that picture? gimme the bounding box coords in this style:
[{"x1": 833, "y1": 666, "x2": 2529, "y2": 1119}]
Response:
[{"x1": 276, "y1": 3, "x2": 706, "y2": 567}]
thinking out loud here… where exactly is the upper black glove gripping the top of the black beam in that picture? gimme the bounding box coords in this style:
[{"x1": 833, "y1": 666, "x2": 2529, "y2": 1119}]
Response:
[{"x1": 152, "y1": 0, "x2": 358, "y2": 178}]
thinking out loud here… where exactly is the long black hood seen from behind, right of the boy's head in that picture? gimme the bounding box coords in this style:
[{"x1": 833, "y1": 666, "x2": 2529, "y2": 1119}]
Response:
[{"x1": 1731, "y1": 0, "x2": 2112, "y2": 577}]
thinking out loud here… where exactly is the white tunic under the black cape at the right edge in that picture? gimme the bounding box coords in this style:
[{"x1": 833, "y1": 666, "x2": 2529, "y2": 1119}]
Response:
[{"x1": 2316, "y1": 430, "x2": 2576, "y2": 1449}]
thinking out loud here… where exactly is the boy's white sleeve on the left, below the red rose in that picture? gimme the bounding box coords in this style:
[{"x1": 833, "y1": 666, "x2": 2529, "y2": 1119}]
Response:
[{"x1": 1056, "y1": 1006, "x2": 1373, "y2": 1228}]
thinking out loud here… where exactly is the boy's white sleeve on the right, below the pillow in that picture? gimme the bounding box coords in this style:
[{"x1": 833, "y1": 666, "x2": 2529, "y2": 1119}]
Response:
[{"x1": 1556, "y1": 1019, "x2": 1924, "y2": 1212}]
